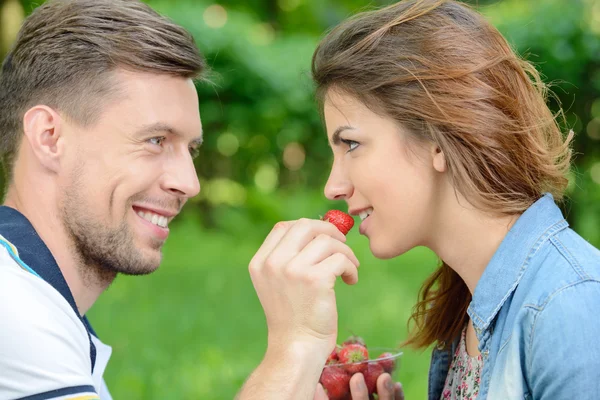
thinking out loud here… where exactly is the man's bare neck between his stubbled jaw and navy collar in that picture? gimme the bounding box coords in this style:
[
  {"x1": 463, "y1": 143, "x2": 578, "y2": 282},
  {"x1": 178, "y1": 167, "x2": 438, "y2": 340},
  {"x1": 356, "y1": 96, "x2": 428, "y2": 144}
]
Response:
[{"x1": 4, "y1": 185, "x2": 111, "y2": 315}]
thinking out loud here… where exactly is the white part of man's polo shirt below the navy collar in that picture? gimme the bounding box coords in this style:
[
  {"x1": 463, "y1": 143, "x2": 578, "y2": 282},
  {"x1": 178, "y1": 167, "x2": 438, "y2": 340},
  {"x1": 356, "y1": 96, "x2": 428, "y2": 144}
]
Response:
[{"x1": 0, "y1": 235, "x2": 112, "y2": 400}]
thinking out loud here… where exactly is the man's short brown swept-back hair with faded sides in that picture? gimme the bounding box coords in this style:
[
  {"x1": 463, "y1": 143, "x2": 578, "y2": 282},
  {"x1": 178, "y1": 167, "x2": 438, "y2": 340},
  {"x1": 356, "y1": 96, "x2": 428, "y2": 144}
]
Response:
[{"x1": 0, "y1": 0, "x2": 205, "y2": 179}]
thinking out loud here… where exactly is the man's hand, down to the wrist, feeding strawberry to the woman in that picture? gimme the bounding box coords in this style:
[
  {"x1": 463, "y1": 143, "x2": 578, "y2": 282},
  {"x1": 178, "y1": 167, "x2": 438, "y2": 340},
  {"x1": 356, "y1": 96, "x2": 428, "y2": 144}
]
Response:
[{"x1": 249, "y1": 219, "x2": 359, "y2": 362}]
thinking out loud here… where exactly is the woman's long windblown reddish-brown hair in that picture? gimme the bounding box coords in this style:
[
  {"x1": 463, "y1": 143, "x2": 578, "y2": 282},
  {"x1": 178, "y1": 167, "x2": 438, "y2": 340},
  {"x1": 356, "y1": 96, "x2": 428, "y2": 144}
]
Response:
[{"x1": 312, "y1": 0, "x2": 573, "y2": 347}]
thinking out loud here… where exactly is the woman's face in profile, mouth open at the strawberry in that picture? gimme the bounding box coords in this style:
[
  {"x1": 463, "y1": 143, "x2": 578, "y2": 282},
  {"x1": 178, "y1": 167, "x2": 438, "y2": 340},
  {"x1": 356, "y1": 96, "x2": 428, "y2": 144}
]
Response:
[{"x1": 324, "y1": 90, "x2": 445, "y2": 258}]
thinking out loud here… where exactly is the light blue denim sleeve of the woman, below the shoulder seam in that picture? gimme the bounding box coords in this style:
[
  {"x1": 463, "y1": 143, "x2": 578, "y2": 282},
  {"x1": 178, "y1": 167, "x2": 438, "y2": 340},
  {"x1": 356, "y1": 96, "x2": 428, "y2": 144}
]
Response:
[{"x1": 521, "y1": 278, "x2": 600, "y2": 398}]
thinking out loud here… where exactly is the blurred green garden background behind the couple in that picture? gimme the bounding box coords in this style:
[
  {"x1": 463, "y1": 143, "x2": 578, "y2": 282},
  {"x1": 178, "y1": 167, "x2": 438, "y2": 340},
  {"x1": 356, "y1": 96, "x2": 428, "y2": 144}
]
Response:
[{"x1": 0, "y1": 0, "x2": 600, "y2": 400}]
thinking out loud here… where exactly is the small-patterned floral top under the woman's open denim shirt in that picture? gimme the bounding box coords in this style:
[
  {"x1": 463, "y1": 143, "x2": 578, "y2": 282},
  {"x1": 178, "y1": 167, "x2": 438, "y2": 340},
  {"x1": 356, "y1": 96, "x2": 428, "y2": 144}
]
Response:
[{"x1": 440, "y1": 326, "x2": 483, "y2": 400}]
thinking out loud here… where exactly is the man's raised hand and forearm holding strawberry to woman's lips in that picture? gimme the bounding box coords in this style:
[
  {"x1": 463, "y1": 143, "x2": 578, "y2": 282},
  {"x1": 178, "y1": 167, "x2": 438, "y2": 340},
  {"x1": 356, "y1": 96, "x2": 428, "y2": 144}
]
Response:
[{"x1": 238, "y1": 219, "x2": 359, "y2": 400}]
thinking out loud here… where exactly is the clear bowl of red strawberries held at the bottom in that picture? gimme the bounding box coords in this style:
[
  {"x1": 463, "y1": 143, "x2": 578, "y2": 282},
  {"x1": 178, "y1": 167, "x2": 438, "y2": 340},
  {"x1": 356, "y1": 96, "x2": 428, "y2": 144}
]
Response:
[{"x1": 319, "y1": 336, "x2": 402, "y2": 400}]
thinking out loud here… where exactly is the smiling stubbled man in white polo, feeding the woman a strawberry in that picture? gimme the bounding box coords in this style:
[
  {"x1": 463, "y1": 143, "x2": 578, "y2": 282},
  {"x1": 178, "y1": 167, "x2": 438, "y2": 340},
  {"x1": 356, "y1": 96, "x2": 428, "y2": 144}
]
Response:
[{"x1": 0, "y1": 0, "x2": 404, "y2": 400}]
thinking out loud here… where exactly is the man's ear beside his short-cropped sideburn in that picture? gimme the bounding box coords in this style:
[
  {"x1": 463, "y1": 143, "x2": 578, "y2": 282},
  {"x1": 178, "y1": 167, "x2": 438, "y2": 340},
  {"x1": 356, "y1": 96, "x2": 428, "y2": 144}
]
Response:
[{"x1": 23, "y1": 105, "x2": 64, "y2": 172}]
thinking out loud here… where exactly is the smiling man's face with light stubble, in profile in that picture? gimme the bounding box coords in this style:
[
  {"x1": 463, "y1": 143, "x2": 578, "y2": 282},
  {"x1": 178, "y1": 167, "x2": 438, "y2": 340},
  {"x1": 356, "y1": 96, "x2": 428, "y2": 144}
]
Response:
[{"x1": 59, "y1": 71, "x2": 202, "y2": 275}]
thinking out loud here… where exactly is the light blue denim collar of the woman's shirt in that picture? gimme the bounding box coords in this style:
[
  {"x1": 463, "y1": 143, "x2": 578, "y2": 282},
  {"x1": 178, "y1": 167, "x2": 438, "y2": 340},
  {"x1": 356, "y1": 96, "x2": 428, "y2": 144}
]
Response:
[{"x1": 467, "y1": 193, "x2": 569, "y2": 334}]
